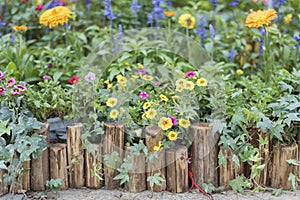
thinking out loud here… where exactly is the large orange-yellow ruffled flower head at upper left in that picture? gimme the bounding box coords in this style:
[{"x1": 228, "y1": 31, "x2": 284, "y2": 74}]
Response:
[{"x1": 40, "y1": 6, "x2": 73, "y2": 28}]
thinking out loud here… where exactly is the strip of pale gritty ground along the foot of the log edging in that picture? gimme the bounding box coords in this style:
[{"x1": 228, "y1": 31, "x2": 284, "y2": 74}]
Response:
[{"x1": 0, "y1": 189, "x2": 300, "y2": 200}]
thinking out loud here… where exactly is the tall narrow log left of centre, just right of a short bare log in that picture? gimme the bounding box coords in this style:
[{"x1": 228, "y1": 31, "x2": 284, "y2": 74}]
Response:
[{"x1": 67, "y1": 124, "x2": 85, "y2": 188}]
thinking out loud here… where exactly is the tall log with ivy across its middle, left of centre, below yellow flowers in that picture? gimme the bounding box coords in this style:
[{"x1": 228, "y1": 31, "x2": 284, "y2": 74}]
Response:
[{"x1": 103, "y1": 122, "x2": 125, "y2": 190}]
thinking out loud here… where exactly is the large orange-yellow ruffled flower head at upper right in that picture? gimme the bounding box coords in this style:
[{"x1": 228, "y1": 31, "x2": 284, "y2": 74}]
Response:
[{"x1": 245, "y1": 9, "x2": 277, "y2": 28}]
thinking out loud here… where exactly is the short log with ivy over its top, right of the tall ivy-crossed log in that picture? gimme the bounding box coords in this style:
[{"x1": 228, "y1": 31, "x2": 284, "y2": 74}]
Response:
[{"x1": 125, "y1": 149, "x2": 147, "y2": 193}]
